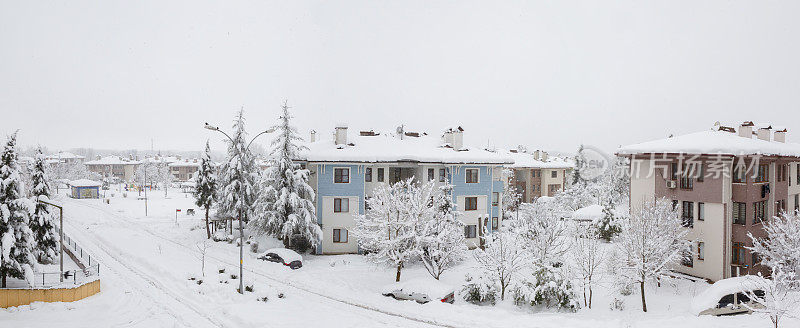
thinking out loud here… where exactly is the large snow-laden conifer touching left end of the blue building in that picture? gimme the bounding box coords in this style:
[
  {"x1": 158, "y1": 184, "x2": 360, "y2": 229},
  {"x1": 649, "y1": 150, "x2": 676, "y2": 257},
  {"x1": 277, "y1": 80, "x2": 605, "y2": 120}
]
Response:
[{"x1": 250, "y1": 103, "x2": 322, "y2": 251}]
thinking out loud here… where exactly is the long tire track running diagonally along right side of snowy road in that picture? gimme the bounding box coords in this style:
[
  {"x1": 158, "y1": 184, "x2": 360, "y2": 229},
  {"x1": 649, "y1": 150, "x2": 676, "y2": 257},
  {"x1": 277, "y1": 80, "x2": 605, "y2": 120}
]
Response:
[{"x1": 65, "y1": 200, "x2": 463, "y2": 328}]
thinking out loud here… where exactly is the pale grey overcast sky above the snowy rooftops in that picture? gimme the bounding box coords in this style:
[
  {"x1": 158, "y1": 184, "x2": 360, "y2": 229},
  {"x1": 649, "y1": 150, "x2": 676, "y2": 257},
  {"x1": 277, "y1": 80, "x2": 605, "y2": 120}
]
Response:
[{"x1": 0, "y1": 0, "x2": 800, "y2": 151}]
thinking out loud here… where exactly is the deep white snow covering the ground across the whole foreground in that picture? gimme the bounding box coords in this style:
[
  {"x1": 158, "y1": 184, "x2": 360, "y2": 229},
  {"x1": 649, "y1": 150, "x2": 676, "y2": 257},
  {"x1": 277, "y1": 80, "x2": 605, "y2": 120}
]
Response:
[{"x1": 0, "y1": 186, "x2": 800, "y2": 328}]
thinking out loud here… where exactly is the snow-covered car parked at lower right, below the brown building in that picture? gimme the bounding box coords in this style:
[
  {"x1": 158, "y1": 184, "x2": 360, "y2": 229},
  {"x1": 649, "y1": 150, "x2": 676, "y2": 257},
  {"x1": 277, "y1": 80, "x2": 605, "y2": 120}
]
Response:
[{"x1": 692, "y1": 276, "x2": 767, "y2": 316}]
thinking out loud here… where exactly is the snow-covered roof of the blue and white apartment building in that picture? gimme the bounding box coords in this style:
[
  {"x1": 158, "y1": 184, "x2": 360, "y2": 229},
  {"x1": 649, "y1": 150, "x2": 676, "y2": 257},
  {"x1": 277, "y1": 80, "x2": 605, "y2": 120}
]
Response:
[{"x1": 298, "y1": 128, "x2": 512, "y2": 164}]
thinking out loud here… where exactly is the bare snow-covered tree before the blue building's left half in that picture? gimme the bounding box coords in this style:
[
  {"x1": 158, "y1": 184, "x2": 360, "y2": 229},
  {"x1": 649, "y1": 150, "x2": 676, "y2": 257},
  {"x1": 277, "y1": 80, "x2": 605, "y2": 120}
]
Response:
[{"x1": 353, "y1": 178, "x2": 422, "y2": 281}]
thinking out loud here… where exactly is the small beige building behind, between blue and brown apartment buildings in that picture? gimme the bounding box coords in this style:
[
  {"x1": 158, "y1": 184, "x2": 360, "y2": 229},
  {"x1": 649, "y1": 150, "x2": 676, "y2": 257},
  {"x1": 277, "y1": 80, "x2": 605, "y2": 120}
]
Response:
[{"x1": 505, "y1": 147, "x2": 575, "y2": 203}]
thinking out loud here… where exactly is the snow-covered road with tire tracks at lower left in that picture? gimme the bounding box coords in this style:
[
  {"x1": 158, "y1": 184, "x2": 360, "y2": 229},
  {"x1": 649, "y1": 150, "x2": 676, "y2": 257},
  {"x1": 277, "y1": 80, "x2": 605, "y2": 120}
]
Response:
[{"x1": 6, "y1": 199, "x2": 440, "y2": 327}]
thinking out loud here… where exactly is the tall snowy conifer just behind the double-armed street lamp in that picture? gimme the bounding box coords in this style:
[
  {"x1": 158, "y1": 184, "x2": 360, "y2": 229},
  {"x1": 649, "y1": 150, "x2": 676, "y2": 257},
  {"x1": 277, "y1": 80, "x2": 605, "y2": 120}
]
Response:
[{"x1": 217, "y1": 109, "x2": 258, "y2": 223}]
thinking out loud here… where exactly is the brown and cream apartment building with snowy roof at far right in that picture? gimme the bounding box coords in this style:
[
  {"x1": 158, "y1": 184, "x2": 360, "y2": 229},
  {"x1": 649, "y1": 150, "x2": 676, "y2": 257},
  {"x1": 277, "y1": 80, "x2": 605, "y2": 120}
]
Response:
[{"x1": 617, "y1": 121, "x2": 800, "y2": 280}]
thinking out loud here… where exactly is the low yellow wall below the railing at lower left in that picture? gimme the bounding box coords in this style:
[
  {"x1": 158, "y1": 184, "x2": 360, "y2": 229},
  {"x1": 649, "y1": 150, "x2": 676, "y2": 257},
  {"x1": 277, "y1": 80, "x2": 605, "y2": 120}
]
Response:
[{"x1": 0, "y1": 280, "x2": 100, "y2": 308}]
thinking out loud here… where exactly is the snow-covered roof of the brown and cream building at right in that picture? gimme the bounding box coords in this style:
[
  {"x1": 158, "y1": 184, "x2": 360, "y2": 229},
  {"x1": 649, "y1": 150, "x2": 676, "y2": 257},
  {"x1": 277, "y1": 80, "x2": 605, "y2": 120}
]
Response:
[{"x1": 617, "y1": 130, "x2": 800, "y2": 157}]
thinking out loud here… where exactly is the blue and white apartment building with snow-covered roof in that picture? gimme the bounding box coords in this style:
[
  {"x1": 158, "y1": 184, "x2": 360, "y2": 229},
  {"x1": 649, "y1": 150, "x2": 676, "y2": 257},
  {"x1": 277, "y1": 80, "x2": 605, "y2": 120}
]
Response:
[{"x1": 303, "y1": 124, "x2": 511, "y2": 254}]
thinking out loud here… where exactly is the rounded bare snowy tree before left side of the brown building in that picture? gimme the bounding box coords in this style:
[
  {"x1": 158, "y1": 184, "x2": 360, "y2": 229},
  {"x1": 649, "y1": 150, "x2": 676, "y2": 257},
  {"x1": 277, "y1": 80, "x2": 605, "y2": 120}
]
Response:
[{"x1": 614, "y1": 198, "x2": 689, "y2": 312}]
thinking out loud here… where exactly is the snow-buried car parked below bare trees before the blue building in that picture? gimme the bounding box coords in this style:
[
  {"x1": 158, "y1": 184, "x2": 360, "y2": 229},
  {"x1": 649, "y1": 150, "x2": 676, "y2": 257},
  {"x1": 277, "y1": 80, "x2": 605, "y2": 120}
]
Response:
[{"x1": 382, "y1": 278, "x2": 455, "y2": 304}]
